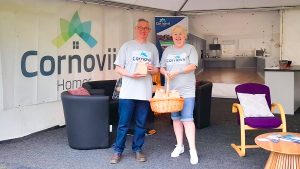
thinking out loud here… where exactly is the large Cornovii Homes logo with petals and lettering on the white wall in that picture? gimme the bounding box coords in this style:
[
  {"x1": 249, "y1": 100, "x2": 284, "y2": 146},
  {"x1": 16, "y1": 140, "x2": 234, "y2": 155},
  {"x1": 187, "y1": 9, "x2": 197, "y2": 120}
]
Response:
[{"x1": 20, "y1": 11, "x2": 117, "y2": 91}]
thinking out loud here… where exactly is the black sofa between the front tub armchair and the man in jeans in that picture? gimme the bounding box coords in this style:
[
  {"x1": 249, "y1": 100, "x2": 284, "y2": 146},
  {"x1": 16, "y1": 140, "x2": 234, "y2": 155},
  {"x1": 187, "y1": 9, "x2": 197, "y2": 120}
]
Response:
[{"x1": 82, "y1": 80, "x2": 119, "y2": 126}]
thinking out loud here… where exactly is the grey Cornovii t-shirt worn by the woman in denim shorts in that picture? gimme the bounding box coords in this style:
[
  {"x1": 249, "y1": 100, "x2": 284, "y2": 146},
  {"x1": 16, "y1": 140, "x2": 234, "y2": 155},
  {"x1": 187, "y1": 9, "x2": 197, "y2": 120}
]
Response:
[{"x1": 160, "y1": 44, "x2": 198, "y2": 98}]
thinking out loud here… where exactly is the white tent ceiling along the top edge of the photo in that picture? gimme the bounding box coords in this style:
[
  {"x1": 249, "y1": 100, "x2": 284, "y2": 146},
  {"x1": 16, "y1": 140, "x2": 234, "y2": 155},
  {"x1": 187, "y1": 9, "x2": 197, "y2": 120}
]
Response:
[{"x1": 75, "y1": 0, "x2": 300, "y2": 12}]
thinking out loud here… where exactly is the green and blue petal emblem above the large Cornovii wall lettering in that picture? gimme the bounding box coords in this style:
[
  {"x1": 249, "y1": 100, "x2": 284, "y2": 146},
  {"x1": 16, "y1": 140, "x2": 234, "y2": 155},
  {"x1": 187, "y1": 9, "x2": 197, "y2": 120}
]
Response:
[{"x1": 52, "y1": 11, "x2": 97, "y2": 48}]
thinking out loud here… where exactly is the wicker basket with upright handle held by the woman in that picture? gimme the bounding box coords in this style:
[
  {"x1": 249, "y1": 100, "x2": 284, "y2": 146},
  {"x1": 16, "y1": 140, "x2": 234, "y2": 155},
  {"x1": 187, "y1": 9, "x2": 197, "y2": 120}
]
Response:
[{"x1": 150, "y1": 78, "x2": 184, "y2": 113}]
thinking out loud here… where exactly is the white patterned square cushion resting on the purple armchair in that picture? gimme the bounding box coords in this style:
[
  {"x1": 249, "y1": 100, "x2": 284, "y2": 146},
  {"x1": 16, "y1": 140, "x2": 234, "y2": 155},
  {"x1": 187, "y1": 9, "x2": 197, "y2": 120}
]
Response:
[{"x1": 237, "y1": 93, "x2": 274, "y2": 117}]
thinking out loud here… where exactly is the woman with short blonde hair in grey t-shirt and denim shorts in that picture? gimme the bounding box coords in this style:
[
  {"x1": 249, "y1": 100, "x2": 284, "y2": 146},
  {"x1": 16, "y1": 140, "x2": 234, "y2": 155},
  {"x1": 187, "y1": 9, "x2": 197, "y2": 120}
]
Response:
[{"x1": 160, "y1": 25, "x2": 198, "y2": 164}]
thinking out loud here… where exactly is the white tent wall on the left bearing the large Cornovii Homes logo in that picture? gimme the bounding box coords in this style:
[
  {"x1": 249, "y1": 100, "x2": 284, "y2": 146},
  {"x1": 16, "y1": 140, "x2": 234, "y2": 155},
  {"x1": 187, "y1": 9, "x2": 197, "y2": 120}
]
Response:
[{"x1": 0, "y1": 0, "x2": 169, "y2": 140}]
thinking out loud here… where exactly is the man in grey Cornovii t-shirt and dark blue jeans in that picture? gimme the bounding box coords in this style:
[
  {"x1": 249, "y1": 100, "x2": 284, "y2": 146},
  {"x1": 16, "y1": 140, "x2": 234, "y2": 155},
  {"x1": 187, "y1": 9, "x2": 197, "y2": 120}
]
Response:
[{"x1": 110, "y1": 19, "x2": 159, "y2": 164}]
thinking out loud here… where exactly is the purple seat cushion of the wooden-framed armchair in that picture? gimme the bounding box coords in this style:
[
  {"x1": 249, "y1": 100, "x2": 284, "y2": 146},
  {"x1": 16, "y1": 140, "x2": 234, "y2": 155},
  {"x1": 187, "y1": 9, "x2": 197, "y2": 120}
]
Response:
[{"x1": 245, "y1": 117, "x2": 281, "y2": 129}]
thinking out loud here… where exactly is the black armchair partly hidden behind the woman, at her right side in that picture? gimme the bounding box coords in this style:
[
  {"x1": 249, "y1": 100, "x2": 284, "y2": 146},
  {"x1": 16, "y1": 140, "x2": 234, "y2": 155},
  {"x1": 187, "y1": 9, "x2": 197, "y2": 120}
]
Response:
[{"x1": 194, "y1": 81, "x2": 213, "y2": 129}]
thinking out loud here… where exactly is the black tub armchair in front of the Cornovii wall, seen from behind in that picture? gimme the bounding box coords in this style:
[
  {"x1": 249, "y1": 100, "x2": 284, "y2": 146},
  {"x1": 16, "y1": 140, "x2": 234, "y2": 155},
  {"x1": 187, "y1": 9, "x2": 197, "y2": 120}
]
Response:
[{"x1": 61, "y1": 91, "x2": 109, "y2": 150}]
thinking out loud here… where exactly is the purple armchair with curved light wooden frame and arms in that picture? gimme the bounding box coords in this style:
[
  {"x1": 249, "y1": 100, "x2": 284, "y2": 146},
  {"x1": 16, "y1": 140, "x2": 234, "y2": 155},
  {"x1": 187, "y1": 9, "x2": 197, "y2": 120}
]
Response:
[{"x1": 231, "y1": 83, "x2": 286, "y2": 157}]
